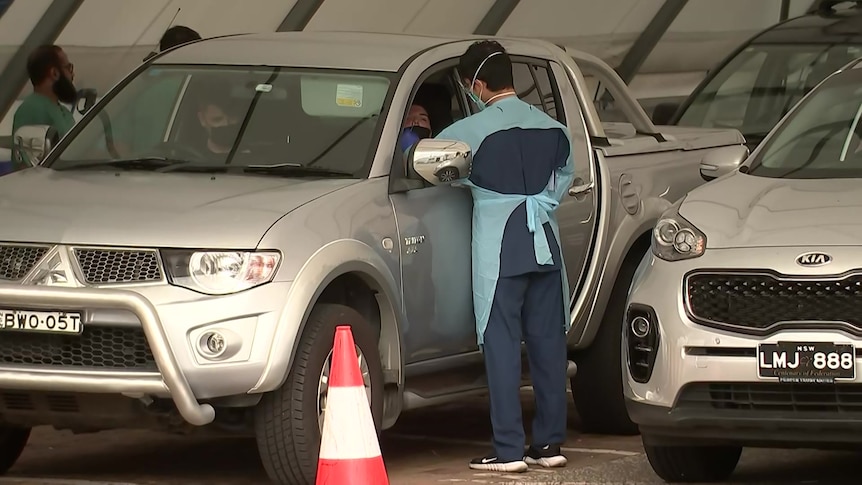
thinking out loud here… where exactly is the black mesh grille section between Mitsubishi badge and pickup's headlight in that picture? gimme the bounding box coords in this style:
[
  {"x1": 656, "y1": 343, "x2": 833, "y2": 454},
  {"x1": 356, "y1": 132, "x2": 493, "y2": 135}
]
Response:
[{"x1": 75, "y1": 248, "x2": 162, "y2": 284}]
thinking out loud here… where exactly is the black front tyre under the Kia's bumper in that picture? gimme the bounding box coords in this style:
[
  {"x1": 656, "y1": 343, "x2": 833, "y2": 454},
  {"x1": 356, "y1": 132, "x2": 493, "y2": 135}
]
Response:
[{"x1": 644, "y1": 444, "x2": 742, "y2": 483}]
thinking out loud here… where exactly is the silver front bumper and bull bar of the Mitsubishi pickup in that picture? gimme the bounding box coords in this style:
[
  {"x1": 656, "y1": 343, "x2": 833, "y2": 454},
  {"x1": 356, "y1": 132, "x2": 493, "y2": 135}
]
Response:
[{"x1": 0, "y1": 283, "x2": 289, "y2": 426}]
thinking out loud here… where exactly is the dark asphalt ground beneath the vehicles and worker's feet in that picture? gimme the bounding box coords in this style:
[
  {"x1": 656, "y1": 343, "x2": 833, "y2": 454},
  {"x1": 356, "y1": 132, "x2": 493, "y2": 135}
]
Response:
[{"x1": 0, "y1": 391, "x2": 862, "y2": 485}]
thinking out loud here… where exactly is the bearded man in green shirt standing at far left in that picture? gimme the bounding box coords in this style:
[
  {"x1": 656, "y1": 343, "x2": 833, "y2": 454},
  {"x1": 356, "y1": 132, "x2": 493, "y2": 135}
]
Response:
[{"x1": 12, "y1": 45, "x2": 78, "y2": 170}]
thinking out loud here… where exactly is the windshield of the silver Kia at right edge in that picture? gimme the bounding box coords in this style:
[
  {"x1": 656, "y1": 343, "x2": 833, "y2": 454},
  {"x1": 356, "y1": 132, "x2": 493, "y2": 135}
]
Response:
[{"x1": 748, "y1": 69, "x2": 862, "y2": 179}]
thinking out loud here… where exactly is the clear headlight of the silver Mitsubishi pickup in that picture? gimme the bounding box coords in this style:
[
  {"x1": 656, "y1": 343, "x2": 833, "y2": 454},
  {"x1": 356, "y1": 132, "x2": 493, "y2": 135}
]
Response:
[{"x1": 162, "y1": 250, "x2": 281, "y2": 295}]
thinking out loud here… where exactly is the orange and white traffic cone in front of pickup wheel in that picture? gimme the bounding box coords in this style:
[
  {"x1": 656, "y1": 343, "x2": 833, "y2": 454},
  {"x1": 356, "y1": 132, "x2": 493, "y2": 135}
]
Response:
[{"x1": 316, "y1": 326, "x2": 389, "y2": 485}]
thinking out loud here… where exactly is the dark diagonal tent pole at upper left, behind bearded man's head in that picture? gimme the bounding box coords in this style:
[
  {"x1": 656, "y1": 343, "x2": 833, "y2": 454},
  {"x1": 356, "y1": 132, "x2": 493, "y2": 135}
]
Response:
[{"x1": 0, "y1": 0, "x2": 84, "y2": 125}]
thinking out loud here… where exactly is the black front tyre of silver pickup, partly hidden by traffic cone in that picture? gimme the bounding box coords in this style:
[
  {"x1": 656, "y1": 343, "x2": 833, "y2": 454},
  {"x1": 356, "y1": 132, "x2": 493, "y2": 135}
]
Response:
[{"x1": 254, "y1": 303, "x2": 383, "y2": 485}]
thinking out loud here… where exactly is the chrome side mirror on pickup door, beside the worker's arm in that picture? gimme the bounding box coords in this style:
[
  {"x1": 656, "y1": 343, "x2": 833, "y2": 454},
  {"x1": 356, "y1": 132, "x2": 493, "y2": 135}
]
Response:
[{"x1": 409, "y1": 138, "x2": 472, "y2": 185}]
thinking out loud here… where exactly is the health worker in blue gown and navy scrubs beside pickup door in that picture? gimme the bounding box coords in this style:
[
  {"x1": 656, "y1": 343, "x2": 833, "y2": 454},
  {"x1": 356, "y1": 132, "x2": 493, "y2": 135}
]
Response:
[{"x1": 436, "y1": 41, "x2": 574, "y2": 472}]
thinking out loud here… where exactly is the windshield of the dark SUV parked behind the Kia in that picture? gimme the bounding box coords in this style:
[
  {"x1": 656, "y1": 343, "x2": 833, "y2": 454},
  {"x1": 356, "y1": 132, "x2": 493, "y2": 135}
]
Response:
[{"x1": 677, "y1": 44, "x2": 862, "y2": 144}]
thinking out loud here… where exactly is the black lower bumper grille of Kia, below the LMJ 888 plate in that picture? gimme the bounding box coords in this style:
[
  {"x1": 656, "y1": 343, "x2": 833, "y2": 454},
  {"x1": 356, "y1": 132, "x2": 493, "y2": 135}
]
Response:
[{"x1": 676, "y1": 382, "x2": 862, "y2": 412}]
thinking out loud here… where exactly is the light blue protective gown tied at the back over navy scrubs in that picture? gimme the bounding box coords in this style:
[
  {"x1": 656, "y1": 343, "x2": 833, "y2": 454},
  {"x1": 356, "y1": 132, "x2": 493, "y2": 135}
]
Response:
[{"x1": 435, "y1": 96, "x2": 575, "y2": 348}]
